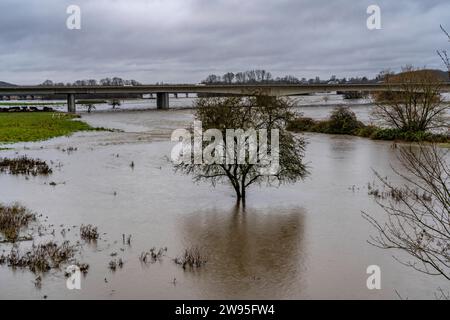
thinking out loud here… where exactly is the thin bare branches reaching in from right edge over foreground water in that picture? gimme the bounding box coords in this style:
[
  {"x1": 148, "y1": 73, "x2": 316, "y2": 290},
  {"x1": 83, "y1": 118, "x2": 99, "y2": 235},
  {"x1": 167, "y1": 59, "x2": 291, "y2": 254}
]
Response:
[{"x1": 363, "y1": 145, "x2": 450, "y2": 280}]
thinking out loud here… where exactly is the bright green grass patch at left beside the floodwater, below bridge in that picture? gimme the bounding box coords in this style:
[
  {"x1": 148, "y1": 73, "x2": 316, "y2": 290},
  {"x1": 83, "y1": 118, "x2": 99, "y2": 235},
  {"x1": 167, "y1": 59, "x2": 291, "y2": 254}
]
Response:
[{"x1": 0, "y1": 112, "x2": 99, "y2": 143}]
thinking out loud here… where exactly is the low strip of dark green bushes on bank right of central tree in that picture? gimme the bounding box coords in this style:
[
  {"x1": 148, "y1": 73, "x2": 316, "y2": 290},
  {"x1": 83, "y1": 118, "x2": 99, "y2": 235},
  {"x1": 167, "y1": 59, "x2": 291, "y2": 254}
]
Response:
[{"x1": 288, "y1": 108, "x2": 450, "y2": 145}]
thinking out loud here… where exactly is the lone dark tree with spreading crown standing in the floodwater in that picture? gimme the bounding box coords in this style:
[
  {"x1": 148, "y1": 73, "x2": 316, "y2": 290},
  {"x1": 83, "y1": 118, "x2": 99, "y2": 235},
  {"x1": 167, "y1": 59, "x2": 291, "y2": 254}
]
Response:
[{"x1": 175, "y1": 95, "x2": 308, "y2": 203}]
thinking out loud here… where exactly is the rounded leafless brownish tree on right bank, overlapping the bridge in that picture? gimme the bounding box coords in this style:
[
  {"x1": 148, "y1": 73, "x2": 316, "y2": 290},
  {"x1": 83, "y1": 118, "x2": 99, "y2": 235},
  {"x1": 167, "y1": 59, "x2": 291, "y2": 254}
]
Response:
[{"x1": 372, "y1": 67, "x2": 449, "y2": 132}]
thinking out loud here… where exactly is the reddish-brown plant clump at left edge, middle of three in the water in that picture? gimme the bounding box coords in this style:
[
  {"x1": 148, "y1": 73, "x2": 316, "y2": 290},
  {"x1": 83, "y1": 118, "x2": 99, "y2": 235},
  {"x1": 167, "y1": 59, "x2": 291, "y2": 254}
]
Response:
[{"x1": 0, "y1": 204, "x2": 36, "y2": 242}]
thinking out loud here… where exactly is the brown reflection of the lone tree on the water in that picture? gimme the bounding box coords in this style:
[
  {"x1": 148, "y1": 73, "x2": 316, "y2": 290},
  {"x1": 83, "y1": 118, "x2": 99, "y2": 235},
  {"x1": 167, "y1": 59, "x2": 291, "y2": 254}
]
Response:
[{"x1": 181, "y1": 207, "x2": 305, "y2": 299}]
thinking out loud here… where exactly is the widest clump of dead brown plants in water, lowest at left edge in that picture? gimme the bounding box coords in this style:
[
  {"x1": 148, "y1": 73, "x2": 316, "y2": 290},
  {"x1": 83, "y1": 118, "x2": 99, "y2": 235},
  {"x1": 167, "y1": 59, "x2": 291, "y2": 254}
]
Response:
[{"x1": 0, "y1": 241, "x2": 76, "y2": 273}]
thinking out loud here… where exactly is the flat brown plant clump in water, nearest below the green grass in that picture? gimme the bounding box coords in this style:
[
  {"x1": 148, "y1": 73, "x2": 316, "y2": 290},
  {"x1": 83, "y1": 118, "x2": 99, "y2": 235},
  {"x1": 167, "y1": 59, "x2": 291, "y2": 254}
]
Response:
[{"x1": 0, "y1": 156, "x2": 52, "y2": 176}]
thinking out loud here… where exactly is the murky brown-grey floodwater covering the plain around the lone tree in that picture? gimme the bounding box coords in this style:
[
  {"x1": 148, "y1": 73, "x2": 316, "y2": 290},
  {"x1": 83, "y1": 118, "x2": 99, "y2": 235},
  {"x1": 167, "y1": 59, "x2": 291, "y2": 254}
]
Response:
[{"x1": 0, "y1": 100, "x2": 449, "y2": 299}]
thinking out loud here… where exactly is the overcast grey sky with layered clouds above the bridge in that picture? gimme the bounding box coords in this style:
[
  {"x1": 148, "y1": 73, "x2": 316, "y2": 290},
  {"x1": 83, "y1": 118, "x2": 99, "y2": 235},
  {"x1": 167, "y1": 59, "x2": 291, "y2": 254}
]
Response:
[{"x1": 0, "y1": 0, "x2": 450, "y2": 84}]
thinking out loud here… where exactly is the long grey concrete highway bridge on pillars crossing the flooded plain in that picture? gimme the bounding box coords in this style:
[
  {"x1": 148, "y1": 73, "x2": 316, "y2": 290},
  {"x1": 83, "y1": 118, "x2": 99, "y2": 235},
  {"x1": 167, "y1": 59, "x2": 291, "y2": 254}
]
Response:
[{"x1": 0, "y1": 83, "x2": 450, "y2": 113}]
